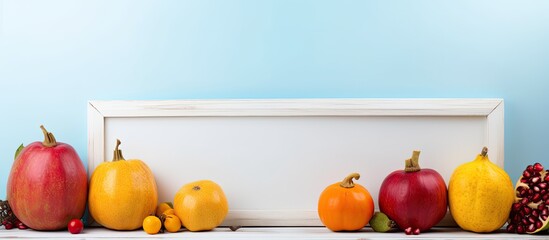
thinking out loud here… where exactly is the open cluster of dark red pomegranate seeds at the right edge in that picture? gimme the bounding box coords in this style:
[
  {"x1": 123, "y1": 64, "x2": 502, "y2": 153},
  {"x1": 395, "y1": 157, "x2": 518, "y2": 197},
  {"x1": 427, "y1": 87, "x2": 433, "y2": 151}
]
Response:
[{"x1": 507, "y1": 163, "x2": 549, "y2": 234}]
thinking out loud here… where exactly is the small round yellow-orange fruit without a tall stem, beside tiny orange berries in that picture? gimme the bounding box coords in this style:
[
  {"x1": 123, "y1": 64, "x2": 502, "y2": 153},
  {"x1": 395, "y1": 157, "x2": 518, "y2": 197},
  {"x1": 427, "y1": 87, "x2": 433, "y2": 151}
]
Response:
[{"x1": 173, "y1": 180, "x2": 229, "y2": 232}]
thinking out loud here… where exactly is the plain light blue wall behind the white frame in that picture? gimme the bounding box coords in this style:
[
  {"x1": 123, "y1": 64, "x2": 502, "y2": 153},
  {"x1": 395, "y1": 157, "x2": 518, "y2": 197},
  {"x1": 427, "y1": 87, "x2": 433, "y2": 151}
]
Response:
[{"x1": 0, "y1": 0, "x2": 549, "y2": 199}]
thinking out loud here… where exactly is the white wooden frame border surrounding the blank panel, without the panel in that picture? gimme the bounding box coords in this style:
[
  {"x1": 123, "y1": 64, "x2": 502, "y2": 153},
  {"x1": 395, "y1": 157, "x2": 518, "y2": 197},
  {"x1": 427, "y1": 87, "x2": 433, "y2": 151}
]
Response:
[{"x1": 88, "y1": 99, "x2": 504, "y2": 226}]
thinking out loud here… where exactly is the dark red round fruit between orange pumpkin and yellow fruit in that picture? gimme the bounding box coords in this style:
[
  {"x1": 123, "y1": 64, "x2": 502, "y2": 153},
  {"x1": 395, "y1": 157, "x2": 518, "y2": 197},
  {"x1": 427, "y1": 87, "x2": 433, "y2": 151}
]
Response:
[{"x1": 379, "y1": 151, "x2": 448, "y2": 234}]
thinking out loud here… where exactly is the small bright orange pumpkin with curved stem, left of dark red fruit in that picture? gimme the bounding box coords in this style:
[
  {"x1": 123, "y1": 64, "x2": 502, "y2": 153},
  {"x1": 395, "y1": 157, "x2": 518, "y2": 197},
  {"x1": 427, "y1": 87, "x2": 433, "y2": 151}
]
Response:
[{"x1": 318, "y1": 173, "x2": 374, "y2": 232}]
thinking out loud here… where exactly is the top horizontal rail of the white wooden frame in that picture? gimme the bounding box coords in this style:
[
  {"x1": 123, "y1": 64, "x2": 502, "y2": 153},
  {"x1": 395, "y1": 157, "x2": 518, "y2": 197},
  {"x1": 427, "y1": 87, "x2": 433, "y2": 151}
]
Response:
[{"x1": 90, "y1": 99, "x2": 502, "y2": 117}]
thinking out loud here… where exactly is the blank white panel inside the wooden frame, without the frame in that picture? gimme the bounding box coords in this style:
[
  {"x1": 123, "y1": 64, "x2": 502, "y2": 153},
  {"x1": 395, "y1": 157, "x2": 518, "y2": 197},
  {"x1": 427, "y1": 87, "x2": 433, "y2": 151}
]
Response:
[{"x1": 105, "y1": 116, "x2": 487, "y2": 211}]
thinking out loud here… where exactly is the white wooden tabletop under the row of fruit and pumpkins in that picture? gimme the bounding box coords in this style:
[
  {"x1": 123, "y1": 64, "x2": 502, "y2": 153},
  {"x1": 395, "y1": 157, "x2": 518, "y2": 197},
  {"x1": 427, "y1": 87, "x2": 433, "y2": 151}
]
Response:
[{"x1": 0, "y1": 227, "x2": 549, "y2": 239}]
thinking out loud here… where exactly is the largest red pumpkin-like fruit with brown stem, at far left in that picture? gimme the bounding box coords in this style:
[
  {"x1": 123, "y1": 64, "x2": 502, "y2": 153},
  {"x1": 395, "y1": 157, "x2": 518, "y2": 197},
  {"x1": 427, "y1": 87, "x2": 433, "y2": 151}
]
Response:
[{"x1": 6, "y1": 126, "x2": 88, "y2": 230}]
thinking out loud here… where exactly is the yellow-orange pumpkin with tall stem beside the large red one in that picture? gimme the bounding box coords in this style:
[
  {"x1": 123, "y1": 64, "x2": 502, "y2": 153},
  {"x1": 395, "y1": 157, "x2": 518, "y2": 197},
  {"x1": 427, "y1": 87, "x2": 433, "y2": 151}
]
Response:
[{"x1": 88, "y1": 140, "x2": 158, "y2": 230}]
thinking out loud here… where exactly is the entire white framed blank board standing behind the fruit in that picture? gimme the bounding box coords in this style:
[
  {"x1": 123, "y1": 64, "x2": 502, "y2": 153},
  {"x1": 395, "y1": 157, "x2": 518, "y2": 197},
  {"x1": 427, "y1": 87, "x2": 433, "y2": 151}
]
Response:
[{"x1": 88, "y1": 99, "x2": 503, "y2": 226}]
